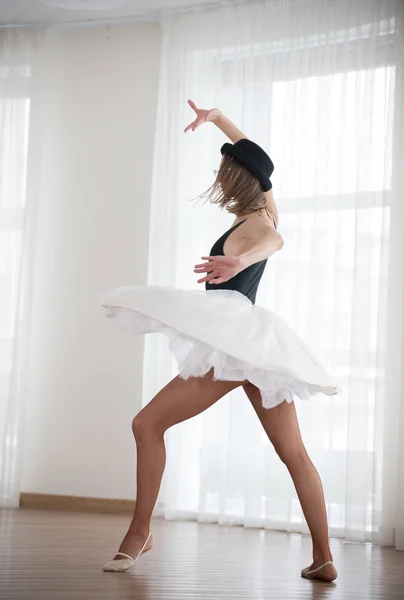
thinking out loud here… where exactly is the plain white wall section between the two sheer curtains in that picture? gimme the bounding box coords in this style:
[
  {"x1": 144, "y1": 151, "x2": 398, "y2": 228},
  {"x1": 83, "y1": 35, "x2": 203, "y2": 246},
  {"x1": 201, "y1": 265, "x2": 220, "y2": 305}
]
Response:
[{"x1": 22, "y1": 24, "x2": 160, "y2": 498}]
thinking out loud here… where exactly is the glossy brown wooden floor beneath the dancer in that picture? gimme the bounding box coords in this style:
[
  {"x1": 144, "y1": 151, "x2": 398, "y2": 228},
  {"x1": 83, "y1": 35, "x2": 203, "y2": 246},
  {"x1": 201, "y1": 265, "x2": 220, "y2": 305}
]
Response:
[{"x1": 0, "y1": 509, "x2": 404, "y2": 600}]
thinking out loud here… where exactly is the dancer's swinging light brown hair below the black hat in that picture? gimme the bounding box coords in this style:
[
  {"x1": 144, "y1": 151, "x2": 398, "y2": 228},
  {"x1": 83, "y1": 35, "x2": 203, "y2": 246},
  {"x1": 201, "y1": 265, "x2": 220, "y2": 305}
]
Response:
[{"x1": 199, "y1": 154, "x2": 266, "y2": 216}]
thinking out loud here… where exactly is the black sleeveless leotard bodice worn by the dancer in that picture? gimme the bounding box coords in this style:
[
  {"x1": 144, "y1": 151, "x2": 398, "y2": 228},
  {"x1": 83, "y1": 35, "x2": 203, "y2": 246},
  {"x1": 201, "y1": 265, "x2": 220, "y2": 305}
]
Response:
[{"x1": 205, "y1": 219, "x2": 268, "y2": 304}]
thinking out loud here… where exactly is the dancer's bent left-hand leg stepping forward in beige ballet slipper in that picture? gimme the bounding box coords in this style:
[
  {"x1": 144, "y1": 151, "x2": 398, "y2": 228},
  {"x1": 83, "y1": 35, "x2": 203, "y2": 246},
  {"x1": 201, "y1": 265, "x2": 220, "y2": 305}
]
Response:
[{"x1": 109, "y1": 371, "x2": 243, "y2": 559}]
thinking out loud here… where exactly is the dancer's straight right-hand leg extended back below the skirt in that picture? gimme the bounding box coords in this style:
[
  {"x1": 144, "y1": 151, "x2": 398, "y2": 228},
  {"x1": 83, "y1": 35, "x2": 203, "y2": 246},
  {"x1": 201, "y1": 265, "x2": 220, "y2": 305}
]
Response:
[{"x1": 243, "y1": 383, "x2": 337, "y2": 581}]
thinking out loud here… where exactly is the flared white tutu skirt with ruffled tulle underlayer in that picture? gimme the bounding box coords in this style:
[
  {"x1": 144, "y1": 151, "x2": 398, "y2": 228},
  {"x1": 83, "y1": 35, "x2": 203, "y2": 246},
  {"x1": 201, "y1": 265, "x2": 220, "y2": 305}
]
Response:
[{"x1": 101, "y1": 286, "x2": 338, "y2": 408}]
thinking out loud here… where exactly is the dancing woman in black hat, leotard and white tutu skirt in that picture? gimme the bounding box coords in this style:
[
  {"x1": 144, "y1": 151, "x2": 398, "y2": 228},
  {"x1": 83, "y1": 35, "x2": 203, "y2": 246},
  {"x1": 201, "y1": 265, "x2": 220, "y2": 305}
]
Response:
[{"x1": 102, "y1": 101, "x2": 337, "y2": 581}]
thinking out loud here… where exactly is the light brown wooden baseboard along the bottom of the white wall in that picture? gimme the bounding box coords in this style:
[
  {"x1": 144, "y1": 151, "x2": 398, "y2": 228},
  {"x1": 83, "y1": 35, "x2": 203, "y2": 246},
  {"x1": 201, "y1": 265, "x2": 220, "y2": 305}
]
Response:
[{"x1": 20, "y1": 492, "x2": 135, "y2": 514}]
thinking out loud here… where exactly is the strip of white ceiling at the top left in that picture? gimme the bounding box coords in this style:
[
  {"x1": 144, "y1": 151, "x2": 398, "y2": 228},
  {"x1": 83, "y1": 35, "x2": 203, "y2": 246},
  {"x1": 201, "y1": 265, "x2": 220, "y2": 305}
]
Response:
[{"x1": 0, "y1": 0, "x2": 237, "y2": 26}]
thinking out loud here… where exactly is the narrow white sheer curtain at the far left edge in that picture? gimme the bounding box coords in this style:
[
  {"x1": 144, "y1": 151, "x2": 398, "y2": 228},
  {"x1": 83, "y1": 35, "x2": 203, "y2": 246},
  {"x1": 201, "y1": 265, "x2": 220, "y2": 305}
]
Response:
[{"x1": 0, "y1": 29, "x2": 37, "y2": 507}]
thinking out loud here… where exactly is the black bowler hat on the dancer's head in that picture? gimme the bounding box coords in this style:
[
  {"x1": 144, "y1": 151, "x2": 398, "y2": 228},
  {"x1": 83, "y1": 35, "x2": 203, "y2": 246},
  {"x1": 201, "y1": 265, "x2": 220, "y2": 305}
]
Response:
[{"x1": 220, "y1": 139, "x2": 274, "y2": 192}]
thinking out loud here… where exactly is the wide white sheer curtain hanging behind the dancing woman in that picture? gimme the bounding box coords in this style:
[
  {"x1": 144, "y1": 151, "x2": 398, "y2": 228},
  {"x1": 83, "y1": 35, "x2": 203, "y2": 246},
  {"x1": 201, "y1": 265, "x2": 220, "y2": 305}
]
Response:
[{"x1": 144, "y1": 0, "x2": 404, "y2": 548}]
